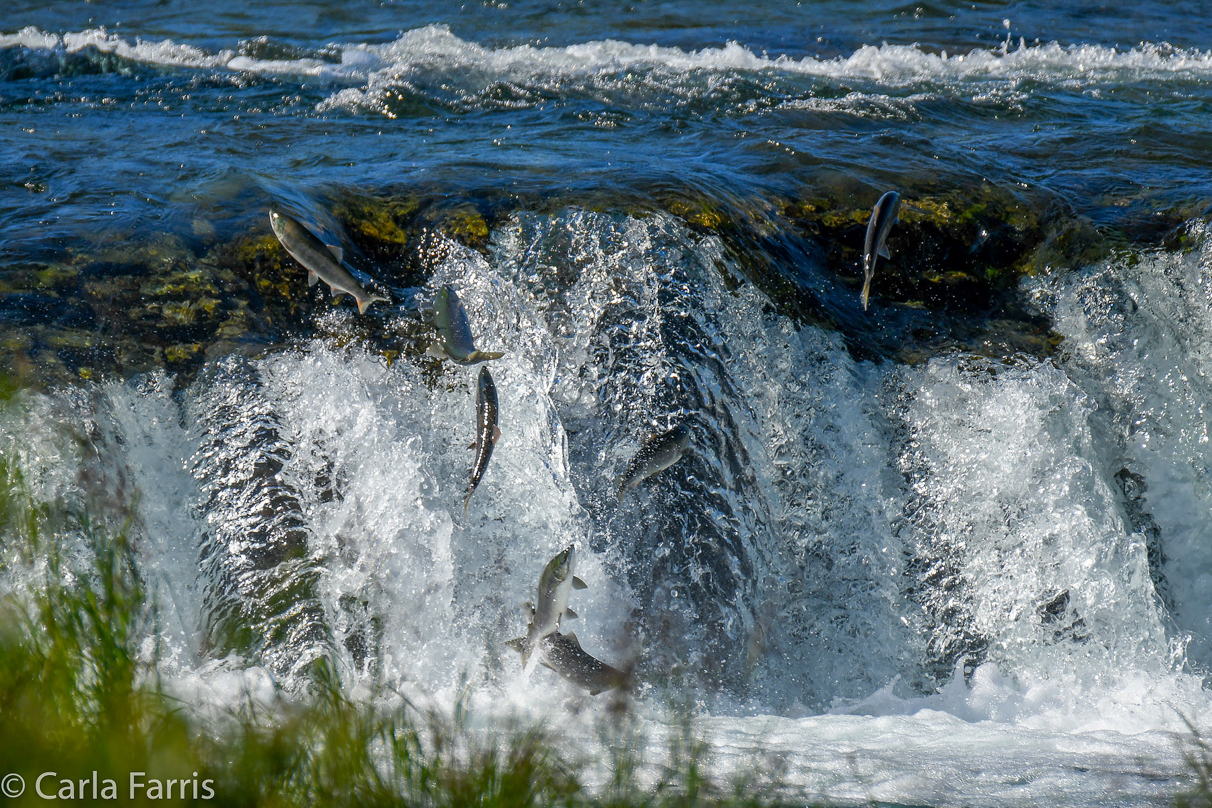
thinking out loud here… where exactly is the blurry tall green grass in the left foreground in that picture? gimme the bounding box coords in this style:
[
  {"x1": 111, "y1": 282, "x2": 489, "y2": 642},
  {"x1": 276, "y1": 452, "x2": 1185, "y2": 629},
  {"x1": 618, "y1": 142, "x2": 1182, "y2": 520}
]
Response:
[{"x1": 0, "y1": 448, "x2": 777, "y2": 808}]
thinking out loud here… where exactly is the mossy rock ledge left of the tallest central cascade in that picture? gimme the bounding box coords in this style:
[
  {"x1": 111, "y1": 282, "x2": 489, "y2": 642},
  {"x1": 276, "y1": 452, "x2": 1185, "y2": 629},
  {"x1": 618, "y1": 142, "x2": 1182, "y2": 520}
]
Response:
[{"x1": 0, "y1": 190, "x2": 492, "y2": 388}]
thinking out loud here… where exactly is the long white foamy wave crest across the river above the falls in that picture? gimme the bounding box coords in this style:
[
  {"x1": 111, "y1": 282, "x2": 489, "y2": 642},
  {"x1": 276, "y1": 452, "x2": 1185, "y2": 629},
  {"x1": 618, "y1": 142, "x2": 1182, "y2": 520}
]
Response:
[{"x1": 0, "y1": 25, "x2": 1212, "y2": 118}]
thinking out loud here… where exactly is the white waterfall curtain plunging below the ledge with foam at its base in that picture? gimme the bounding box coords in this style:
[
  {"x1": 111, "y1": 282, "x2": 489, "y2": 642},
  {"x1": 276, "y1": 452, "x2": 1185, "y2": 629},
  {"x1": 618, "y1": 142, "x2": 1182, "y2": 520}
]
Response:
[{"x1": 4, "y1": 211, "x2": 1212, "y2": 806}]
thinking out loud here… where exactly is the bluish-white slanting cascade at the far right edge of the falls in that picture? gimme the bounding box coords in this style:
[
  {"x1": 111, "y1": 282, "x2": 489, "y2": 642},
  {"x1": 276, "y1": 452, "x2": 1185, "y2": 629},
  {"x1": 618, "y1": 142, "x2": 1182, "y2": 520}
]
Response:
[{"x1": 1029, "y1": 223, "x2": 1212, "y2": 674}]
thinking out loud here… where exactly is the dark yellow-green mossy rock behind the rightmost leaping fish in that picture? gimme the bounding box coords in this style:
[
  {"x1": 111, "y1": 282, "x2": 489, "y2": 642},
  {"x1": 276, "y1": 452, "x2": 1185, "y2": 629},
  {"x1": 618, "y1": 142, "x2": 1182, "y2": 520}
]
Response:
[{"x1": 762, "y1": 179, "x2": 1058, "y2": 362}]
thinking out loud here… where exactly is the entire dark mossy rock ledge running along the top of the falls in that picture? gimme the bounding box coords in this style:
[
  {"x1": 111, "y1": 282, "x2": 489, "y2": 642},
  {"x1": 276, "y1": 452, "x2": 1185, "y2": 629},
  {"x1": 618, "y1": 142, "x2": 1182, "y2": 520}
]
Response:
[{"x1": 0, "y1": 178, "x2": 1183, "y2": 386}]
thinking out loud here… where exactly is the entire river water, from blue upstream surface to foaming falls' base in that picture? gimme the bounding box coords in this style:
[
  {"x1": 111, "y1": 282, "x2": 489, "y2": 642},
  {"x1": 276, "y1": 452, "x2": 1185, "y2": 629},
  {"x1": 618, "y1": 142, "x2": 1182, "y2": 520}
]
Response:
[{"x1": 0, "y1": 0, "x2": 1212, "y2": 806}]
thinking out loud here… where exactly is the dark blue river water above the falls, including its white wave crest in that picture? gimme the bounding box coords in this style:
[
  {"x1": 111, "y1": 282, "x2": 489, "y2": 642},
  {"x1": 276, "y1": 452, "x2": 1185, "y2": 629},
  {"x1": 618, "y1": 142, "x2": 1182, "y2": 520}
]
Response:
[{"x1": 0, "y1": 0, "x2": 1212, "y2": 262}]
